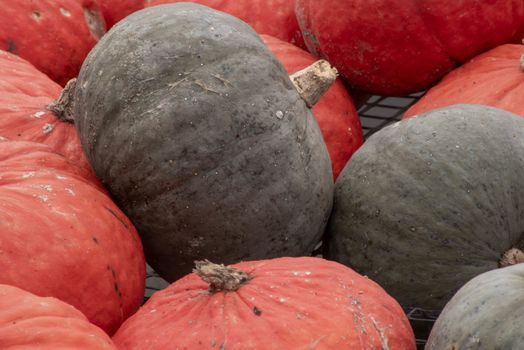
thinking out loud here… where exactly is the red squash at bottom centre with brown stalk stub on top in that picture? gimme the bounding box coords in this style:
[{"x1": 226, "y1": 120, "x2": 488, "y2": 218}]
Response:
[{"x1": 113, "y1": 257, "x2": 415, "y2": 350}]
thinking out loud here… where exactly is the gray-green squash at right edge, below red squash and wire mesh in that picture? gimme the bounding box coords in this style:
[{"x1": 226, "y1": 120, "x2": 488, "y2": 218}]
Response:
[{"x1": 325, "y1": 105, "x2": 524, "y2": 311}]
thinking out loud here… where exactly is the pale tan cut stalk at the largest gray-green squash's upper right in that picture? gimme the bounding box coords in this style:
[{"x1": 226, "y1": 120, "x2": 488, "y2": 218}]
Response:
[{"x1": 289, "y1": 60, "x2": 338, "y2": 108}]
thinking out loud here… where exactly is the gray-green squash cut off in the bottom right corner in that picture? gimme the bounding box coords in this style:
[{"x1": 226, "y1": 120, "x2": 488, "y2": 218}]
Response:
[{"x1": 425, "y1": 264, "x2": 524, "y2": 350}]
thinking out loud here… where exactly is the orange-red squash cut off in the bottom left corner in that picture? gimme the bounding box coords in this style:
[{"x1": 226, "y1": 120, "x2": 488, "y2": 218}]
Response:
[{"x1": 0, "y1": 284, "x2": 117, "y2": 350}]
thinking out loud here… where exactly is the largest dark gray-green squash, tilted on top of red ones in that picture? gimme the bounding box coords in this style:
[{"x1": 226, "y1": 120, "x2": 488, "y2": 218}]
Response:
[{"x1": 74, "y1": 3, "x2": 333, "y2": 280}]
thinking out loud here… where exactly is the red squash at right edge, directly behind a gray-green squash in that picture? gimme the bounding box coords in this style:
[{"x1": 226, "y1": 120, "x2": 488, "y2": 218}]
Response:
[{"x1": 405, "y1": 44, "x2": 524, "y2": 118}]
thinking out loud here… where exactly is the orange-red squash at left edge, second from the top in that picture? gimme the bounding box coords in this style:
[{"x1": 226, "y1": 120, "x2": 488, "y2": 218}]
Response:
[{"x1": 0, "y1": 50, "x2": 99, "y2": 184}]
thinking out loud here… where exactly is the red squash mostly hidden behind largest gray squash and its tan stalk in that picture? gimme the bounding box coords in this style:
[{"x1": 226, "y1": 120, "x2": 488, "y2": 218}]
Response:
[{"x1": 261, "y1": 35, "x2": 363, "y2": 179}]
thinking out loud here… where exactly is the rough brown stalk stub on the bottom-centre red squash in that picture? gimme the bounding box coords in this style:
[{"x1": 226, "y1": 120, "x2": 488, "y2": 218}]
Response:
[{"x1": 193, "y1": 260, "x2": 251, "y2": 293}]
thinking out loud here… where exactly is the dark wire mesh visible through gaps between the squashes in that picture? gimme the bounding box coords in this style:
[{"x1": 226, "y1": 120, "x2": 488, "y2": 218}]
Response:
[{"x1": 144, "y1": 92, "x2": 438, "y2": 350}]
